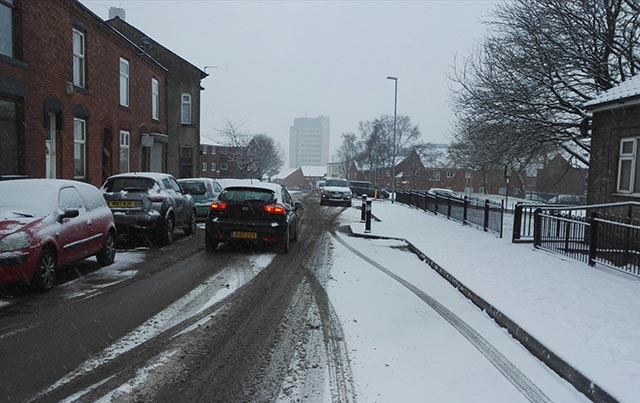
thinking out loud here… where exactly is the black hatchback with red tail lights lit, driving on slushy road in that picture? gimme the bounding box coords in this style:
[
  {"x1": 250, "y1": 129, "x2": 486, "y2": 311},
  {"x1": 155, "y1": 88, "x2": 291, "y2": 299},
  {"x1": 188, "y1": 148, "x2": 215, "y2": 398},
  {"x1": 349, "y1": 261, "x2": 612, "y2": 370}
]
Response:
[{"x1": 205, "y1": 181, "x2": 304, "y2": 253}]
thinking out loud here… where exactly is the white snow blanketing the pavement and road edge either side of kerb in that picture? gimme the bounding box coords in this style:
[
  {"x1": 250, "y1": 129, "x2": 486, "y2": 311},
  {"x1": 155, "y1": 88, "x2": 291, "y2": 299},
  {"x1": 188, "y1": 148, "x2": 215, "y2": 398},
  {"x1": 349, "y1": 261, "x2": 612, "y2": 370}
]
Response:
[{"x1": 328, "y1": 202, "x2": 640, "y2": 402}]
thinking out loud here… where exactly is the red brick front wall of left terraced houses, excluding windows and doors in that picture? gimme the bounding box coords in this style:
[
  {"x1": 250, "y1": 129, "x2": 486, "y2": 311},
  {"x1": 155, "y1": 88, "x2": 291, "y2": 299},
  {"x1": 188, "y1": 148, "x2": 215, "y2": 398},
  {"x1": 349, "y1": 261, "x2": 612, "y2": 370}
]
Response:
[{"x1": 0, "y1": 0, "x2": 166, "y2": 186}]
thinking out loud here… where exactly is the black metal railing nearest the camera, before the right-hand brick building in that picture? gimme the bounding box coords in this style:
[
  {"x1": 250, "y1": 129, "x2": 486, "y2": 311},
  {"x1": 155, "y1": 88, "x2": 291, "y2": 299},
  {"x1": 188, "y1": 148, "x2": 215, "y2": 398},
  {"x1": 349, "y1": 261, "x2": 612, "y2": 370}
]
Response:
[{"x1": 512, "y1": 202, "x2": 640, "y2": 277}]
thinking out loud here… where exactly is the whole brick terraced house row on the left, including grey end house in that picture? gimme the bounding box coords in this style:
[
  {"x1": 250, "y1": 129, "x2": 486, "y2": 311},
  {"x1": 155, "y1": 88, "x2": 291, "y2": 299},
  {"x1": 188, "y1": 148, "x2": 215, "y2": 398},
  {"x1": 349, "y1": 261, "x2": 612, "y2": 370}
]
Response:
[{"x1": 0, "y1": 0, "x2": 207, "y2": 186}]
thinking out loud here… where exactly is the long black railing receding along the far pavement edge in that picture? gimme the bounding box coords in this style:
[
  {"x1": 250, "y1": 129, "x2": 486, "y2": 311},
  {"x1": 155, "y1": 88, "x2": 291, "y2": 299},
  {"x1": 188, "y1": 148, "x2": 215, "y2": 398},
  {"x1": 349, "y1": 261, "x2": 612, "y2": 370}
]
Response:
[{"x1": 396, "y1": 190, "x2": 504, "y2": 238}]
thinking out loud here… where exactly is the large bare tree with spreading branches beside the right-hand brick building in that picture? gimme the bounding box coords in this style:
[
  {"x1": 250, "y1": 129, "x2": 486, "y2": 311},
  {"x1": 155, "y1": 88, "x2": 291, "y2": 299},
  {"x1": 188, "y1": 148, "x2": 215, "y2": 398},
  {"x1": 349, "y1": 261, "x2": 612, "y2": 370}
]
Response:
[{"x1": 451, "y1": 0, "x2": 640, "y2": 164}]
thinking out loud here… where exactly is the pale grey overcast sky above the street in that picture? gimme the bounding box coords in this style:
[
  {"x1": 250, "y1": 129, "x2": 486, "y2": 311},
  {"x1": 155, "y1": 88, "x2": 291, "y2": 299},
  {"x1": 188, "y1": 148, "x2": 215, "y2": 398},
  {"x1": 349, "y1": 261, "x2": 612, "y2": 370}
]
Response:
[{"x1": 81, "y1": 0, "x2": 495, "y2": 164}]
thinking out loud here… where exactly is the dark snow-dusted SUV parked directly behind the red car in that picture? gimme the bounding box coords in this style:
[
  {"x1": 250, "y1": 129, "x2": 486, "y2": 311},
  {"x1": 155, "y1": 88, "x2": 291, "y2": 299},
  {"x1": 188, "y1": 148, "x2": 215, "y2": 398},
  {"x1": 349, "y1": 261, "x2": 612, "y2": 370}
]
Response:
[{"x1": 101, "y1": 172, "x2": 196, "y2": 245}]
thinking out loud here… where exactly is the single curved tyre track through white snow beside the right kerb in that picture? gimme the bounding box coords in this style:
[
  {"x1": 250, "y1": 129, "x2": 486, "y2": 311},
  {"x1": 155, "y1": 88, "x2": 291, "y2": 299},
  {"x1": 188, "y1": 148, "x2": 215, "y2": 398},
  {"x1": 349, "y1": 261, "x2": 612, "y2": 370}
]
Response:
[{"x1": 332, "y1": 233, "x2": 552, "y2": 403}]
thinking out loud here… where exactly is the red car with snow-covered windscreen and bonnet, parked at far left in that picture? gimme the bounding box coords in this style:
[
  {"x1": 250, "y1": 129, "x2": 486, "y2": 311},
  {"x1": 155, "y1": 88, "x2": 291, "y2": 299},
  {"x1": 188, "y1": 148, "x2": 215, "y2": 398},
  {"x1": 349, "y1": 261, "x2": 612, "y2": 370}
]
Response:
[{"x1": 0, "y1": 179, "x2": 116, "y2": 291}]
